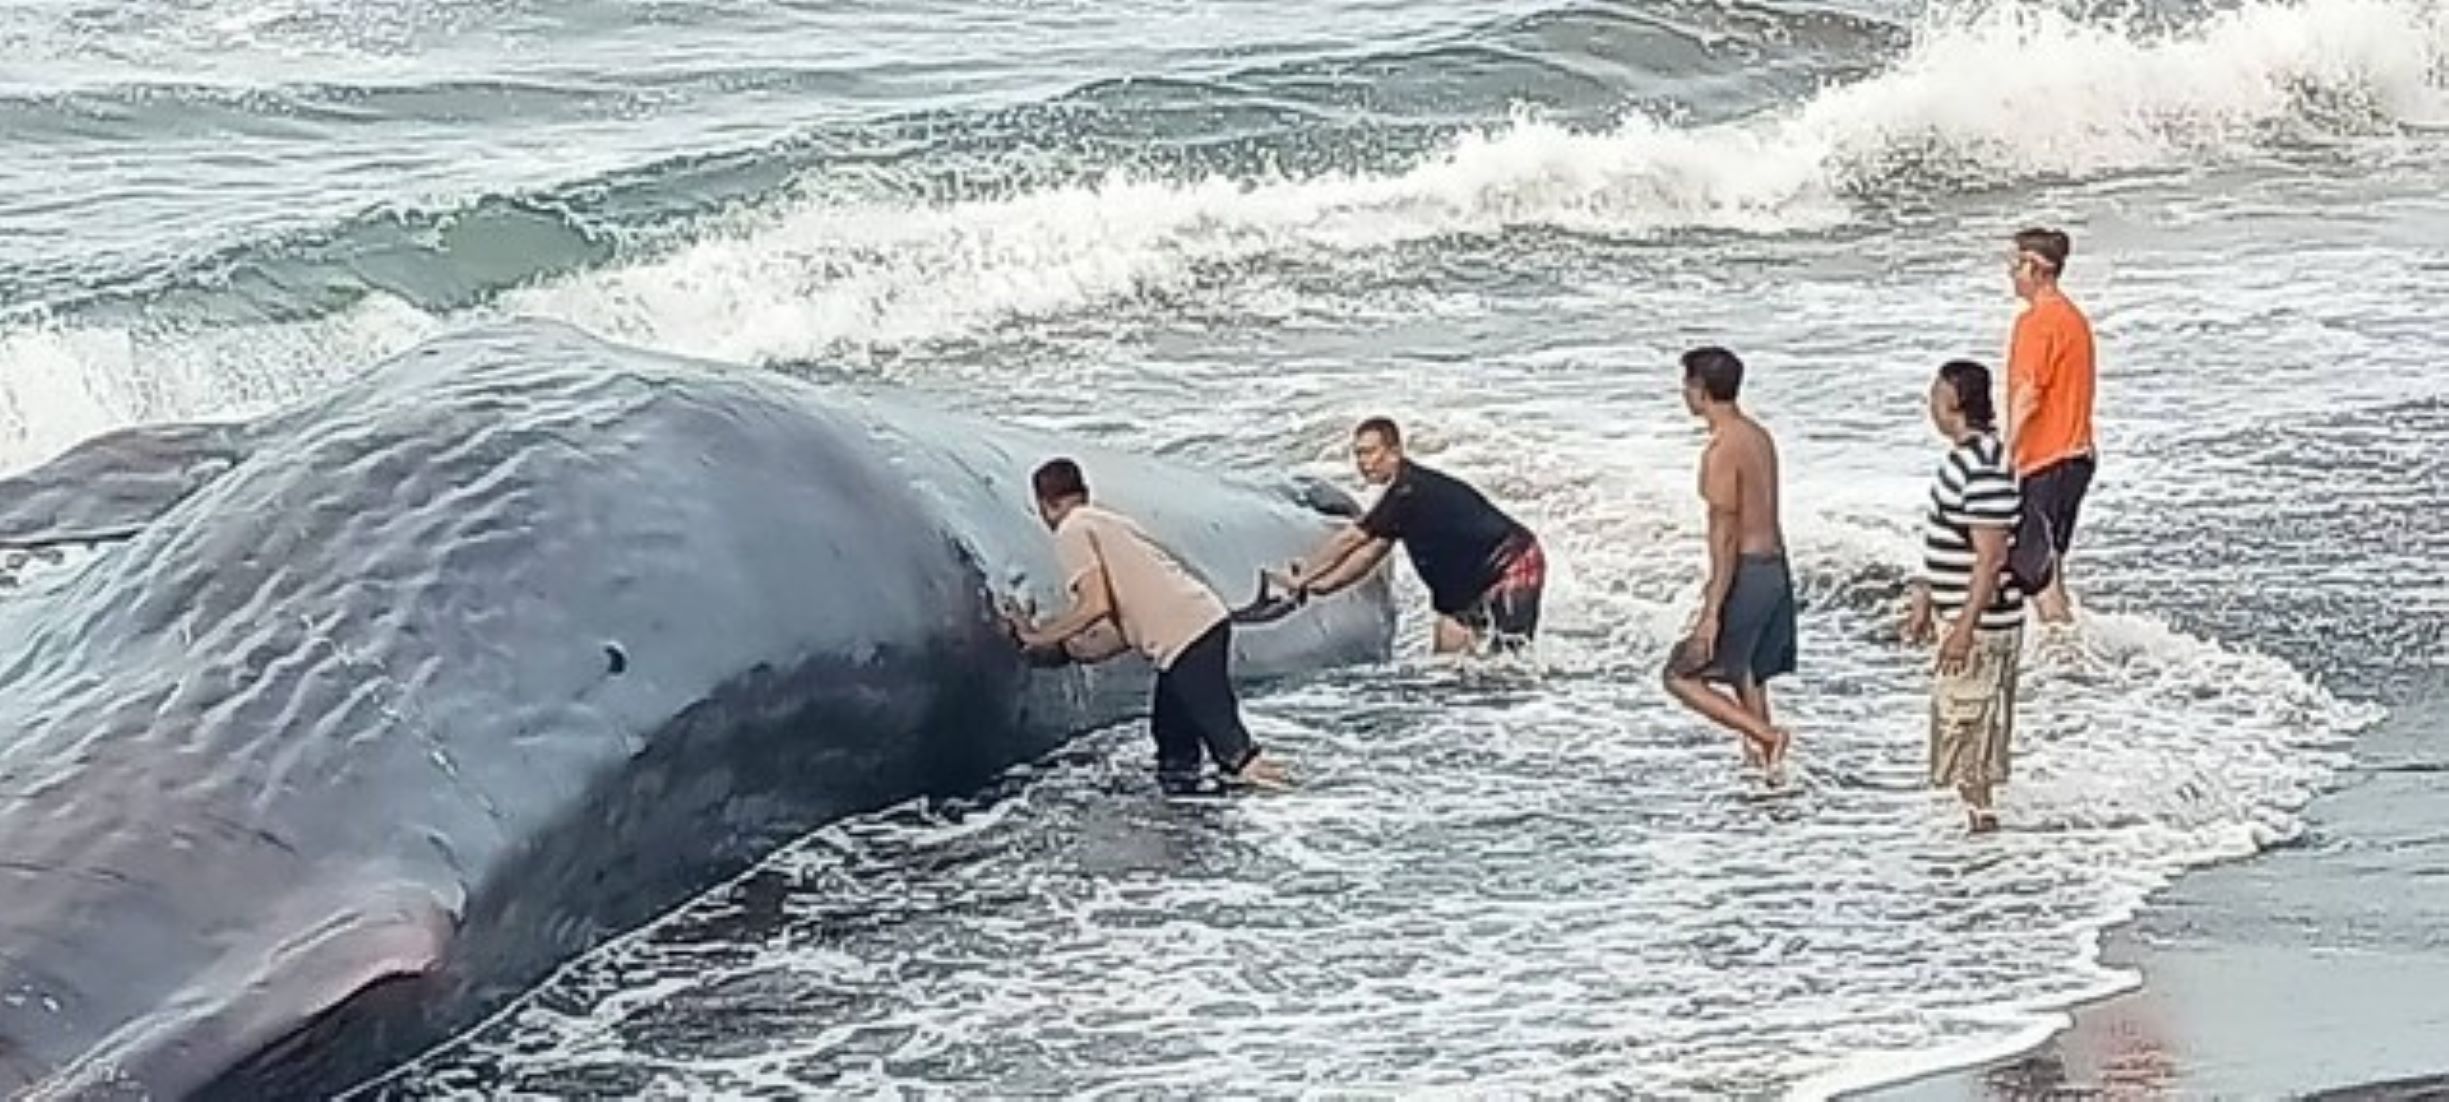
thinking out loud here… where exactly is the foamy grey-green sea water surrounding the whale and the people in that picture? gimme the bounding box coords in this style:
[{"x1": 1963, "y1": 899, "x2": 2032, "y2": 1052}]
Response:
[{"x1": 0, "y1": 0, "x2": 2449, "y2": 1097}]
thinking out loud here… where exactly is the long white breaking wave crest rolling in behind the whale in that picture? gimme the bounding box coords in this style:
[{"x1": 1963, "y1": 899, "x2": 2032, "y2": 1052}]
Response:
[{"x1": 0, "y1": 0, "x2": 2449, "y2": 465}]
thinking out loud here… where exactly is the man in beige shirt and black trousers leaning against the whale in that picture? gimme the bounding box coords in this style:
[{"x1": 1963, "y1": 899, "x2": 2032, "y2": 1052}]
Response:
[{"x1": 1011, "y1": 458, "x2": 1286, "y2": 793}]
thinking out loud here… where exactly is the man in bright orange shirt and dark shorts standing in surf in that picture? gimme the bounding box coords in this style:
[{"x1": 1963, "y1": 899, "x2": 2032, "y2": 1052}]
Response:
[{"x1": 2006, "y1": 230, "x2": 2094, "y2": 624}]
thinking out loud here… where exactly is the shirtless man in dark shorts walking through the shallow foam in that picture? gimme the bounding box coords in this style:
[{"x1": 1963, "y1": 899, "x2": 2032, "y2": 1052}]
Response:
[{"x1": 1665, "y1": 348, "x2": 1795, "y2": 776}]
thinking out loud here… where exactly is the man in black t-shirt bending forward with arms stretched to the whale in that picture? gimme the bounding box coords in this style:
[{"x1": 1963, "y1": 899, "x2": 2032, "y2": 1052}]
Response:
[{"x1": 1281, "y1": 416, "x2": 1548, "y2": 654}]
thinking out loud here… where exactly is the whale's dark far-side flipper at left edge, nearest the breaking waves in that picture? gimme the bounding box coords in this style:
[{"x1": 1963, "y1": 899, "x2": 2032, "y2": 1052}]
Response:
[{"x1": 0, "y1": 424, "x2": 245, "y2": 551}]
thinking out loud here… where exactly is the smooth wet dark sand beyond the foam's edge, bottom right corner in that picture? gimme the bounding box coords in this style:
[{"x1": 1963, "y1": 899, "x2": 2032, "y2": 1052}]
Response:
[{"x1": 1829, "y1": 678, "x2": 2449, "y2": 1102}]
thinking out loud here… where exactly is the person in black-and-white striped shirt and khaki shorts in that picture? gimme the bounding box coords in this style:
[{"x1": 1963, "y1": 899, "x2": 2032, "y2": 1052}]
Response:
[{"x1": 1905, "y1": 360, "x2": 2023, "y2": 833}]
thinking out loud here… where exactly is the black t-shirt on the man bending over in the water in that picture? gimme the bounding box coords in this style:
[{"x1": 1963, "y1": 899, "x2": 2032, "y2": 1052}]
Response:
[{"x1": 1359, "y1": 460, "x2": 1531, "y2": 615}]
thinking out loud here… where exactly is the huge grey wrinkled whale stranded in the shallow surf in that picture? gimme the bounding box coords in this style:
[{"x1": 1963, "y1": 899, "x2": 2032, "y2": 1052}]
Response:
[{"x1": 0, "y1": 321, "x2": 1393, "y2": 1097}]
